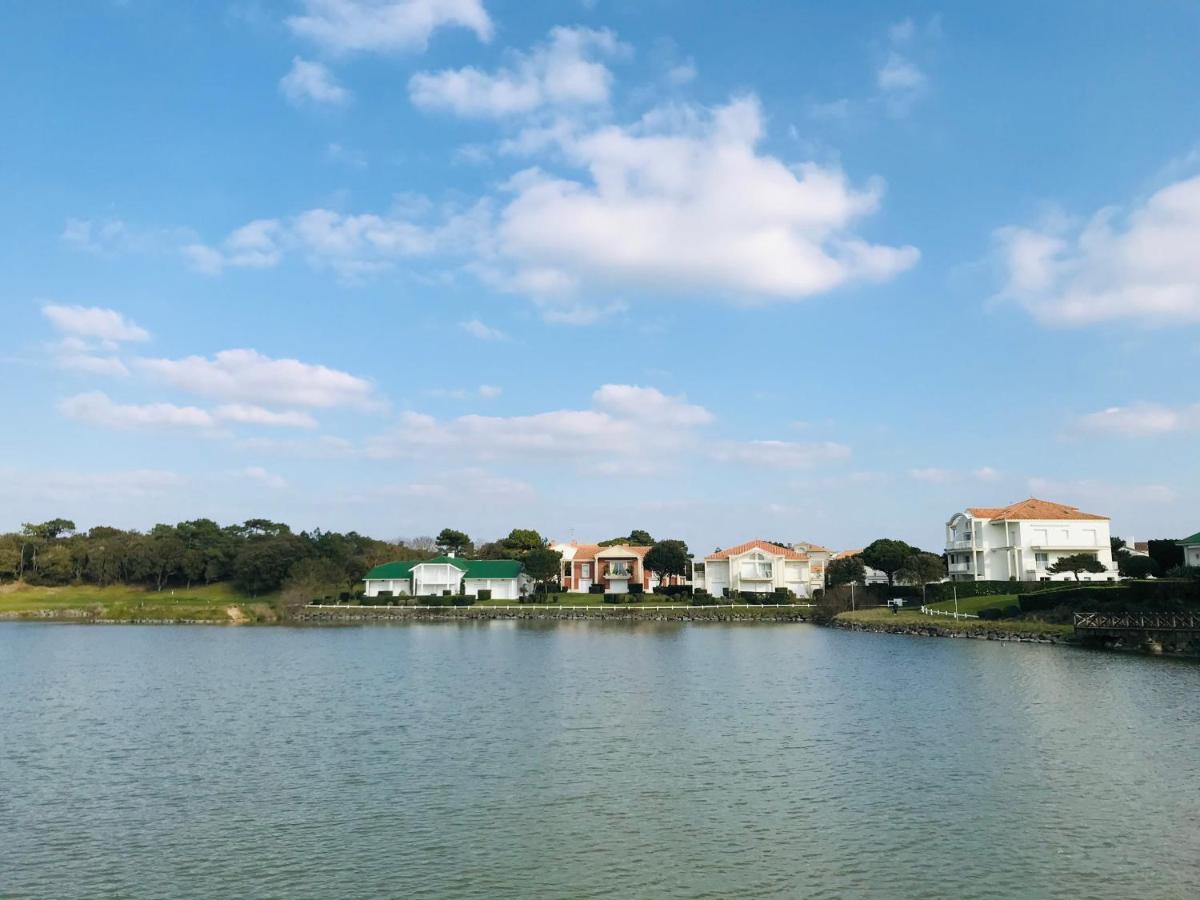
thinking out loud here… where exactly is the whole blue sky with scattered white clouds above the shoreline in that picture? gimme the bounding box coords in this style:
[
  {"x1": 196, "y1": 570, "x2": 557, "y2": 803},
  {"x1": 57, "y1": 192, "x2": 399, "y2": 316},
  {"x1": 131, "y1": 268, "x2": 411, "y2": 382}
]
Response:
[{"x1": 0, "y1": 0, "x2": 1200, "y2": 551}]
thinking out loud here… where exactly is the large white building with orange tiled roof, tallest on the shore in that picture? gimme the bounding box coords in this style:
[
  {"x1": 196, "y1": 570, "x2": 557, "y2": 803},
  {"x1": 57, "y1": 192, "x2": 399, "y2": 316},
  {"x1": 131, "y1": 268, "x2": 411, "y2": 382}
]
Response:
[{"x1": 946, "y1": 497, "x2": 1117, "y2": 581}]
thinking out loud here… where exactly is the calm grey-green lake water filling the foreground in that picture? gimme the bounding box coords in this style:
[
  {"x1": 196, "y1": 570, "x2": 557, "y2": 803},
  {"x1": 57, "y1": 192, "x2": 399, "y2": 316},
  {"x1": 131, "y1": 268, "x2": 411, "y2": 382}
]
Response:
[{"x1": 0, "y1": 623, "x2": 1200, "y2": 898}]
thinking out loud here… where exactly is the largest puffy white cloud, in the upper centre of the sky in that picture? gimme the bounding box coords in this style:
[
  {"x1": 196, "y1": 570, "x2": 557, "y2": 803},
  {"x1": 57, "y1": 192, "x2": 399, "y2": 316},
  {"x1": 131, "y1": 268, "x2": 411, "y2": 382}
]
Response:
[{"x1": 496, "y1": 97, "x2": 919, "y2": 301}]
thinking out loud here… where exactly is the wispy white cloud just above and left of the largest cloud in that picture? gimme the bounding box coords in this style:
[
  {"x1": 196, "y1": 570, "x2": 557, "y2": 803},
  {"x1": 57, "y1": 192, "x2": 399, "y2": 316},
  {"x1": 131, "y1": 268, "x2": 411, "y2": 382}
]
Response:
[{"x1": 408, "y1": 28, "x2": 628, "y2": 119}]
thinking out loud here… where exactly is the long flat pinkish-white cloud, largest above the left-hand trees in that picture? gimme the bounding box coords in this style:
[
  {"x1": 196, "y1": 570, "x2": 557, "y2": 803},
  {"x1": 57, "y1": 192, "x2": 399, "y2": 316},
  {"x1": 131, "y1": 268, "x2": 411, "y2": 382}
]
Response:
[{"x1": 137, "y1": 349, "x2": 378, "y2": 409}]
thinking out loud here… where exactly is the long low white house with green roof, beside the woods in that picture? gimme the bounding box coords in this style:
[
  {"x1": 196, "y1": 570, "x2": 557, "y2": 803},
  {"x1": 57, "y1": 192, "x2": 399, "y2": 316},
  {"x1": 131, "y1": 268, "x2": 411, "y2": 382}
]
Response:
[{"x1": 364, "y1": 556, "x2": 533, "y2": 600}]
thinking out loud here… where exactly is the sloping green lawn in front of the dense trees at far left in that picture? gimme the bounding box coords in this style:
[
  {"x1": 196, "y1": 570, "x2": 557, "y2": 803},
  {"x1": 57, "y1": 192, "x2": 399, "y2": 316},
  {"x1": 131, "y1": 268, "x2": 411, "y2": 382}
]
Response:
[{"x1": 0, "y1": 584, "x2": 275, "y2": 622}]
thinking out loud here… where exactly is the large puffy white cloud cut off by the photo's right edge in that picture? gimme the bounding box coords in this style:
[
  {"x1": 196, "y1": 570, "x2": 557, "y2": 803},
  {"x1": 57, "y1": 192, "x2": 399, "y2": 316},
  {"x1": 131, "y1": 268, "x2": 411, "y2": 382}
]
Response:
[{"x1": 995, "y1": 175, "x2": 1200, "y2": 325}]
